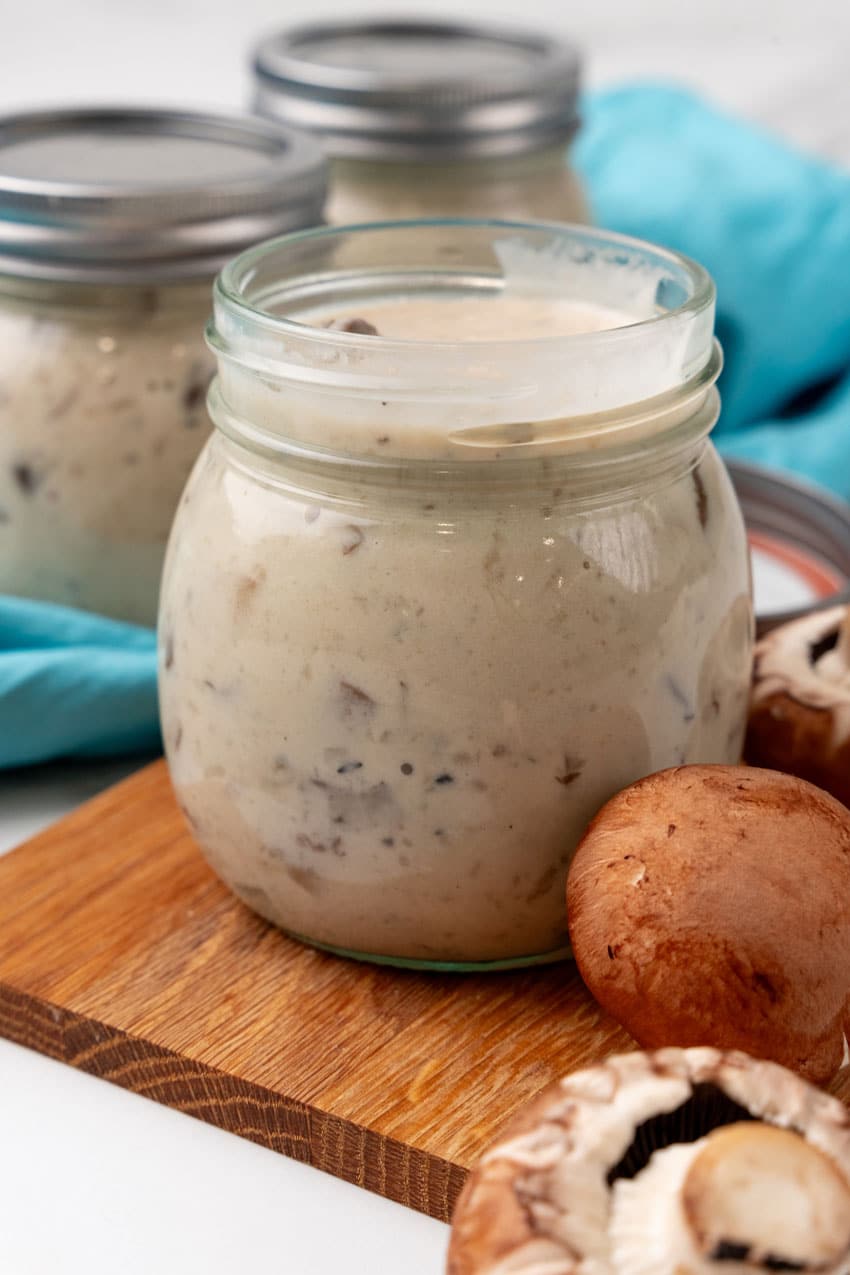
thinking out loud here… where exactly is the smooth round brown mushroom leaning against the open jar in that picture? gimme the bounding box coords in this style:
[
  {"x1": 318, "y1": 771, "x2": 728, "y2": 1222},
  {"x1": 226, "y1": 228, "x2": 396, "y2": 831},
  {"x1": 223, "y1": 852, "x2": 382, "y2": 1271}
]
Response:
[{"x1": 567, "y1": 766, "x2": 850, "y2": 1081}]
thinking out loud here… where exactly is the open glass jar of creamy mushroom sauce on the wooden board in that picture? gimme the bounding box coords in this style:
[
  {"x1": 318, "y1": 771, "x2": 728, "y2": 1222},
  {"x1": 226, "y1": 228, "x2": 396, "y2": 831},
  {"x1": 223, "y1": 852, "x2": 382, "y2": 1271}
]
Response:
[{"x1": 159, "y1": 222, "x2": 752, "y2": 968}]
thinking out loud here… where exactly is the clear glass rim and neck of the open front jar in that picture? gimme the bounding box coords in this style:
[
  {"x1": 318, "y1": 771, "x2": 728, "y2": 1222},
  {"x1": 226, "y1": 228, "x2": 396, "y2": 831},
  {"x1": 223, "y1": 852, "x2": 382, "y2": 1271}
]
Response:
[{"x1": 208, "y1": 218, "x2": 720, "y2": 456}]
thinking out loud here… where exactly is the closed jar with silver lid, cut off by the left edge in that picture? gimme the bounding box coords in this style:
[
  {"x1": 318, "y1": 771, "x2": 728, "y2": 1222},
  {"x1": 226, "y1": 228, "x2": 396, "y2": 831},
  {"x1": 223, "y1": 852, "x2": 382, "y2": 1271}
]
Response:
[{"x1": 0, "y1": 110, "x2": 325, "y2": 623}]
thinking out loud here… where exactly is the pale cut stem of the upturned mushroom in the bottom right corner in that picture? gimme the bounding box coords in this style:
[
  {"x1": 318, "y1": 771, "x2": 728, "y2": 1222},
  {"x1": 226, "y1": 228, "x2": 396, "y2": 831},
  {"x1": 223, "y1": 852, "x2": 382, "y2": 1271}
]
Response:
[{"x1": 609, "y1": 1119, "x2": 850, "y2": 1275}]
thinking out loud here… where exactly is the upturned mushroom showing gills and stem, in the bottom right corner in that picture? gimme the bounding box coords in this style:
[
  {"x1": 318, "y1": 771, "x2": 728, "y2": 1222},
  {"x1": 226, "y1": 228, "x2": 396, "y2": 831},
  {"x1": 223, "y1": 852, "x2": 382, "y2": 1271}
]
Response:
[{"x1": 447, "y1": 1048, "x2": 850, "y2": 1275}]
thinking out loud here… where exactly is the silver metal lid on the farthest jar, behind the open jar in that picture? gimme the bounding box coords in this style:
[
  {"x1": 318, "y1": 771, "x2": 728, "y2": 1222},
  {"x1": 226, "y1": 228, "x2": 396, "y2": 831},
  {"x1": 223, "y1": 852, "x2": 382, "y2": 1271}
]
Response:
[{"x1": 254, "y1": 20, "x2": 581, "y2": 159}]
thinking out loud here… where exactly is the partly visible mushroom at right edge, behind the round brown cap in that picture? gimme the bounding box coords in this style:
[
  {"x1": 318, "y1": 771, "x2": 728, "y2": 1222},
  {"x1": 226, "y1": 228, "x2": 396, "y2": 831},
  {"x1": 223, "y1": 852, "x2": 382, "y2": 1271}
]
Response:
[{"x1": 746, "y1": 607, "x2": 850, "y2": 806}]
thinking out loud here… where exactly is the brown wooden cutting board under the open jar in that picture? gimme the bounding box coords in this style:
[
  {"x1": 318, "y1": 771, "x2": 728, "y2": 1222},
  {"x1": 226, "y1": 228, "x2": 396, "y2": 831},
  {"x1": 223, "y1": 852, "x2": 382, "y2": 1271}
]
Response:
[{"x1": 0, "y1": 761, "x2": 850, "y2": 1220}]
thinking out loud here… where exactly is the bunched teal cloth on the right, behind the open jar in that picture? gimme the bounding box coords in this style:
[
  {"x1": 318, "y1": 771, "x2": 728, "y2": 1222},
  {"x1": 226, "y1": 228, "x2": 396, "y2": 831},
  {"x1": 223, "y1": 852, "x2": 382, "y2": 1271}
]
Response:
[{"x1": 575, "y1": 85, "x2": 850, "y2": 499}]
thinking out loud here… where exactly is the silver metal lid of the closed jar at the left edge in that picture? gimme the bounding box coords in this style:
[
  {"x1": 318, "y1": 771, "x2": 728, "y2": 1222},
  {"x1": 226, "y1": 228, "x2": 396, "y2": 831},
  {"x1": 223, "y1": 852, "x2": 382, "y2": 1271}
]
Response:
[{"x1": 0, "y1": 108, "x2": 326, "y2": 282}]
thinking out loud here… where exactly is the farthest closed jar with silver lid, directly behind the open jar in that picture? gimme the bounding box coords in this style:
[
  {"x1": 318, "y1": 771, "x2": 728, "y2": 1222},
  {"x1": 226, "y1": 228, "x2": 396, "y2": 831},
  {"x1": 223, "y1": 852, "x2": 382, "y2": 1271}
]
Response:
[{"x1": 254, "y1": 20, "x2": 587, "y2": 224}]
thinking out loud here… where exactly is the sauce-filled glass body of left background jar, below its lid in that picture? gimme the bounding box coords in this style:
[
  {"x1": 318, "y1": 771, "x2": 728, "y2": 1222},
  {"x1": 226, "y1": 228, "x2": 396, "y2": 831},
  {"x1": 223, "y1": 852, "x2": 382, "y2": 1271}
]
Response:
[{"x1": 0, "y1": 279, "x2": 213, "y2": 623}]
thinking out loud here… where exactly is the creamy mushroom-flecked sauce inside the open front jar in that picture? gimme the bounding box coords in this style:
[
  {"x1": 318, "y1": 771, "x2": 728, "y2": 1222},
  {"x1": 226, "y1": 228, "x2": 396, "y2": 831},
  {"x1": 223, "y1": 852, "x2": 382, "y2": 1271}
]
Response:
[{"x1": 161, "y1": 297, "x2": 751, "y2": 961}]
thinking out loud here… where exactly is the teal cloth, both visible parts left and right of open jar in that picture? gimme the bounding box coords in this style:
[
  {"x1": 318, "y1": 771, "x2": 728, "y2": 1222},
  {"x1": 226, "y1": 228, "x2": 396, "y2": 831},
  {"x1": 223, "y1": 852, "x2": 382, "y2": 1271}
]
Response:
[{"x1": 0, "y1": 85, "x2": 850, "y2": 766}]
